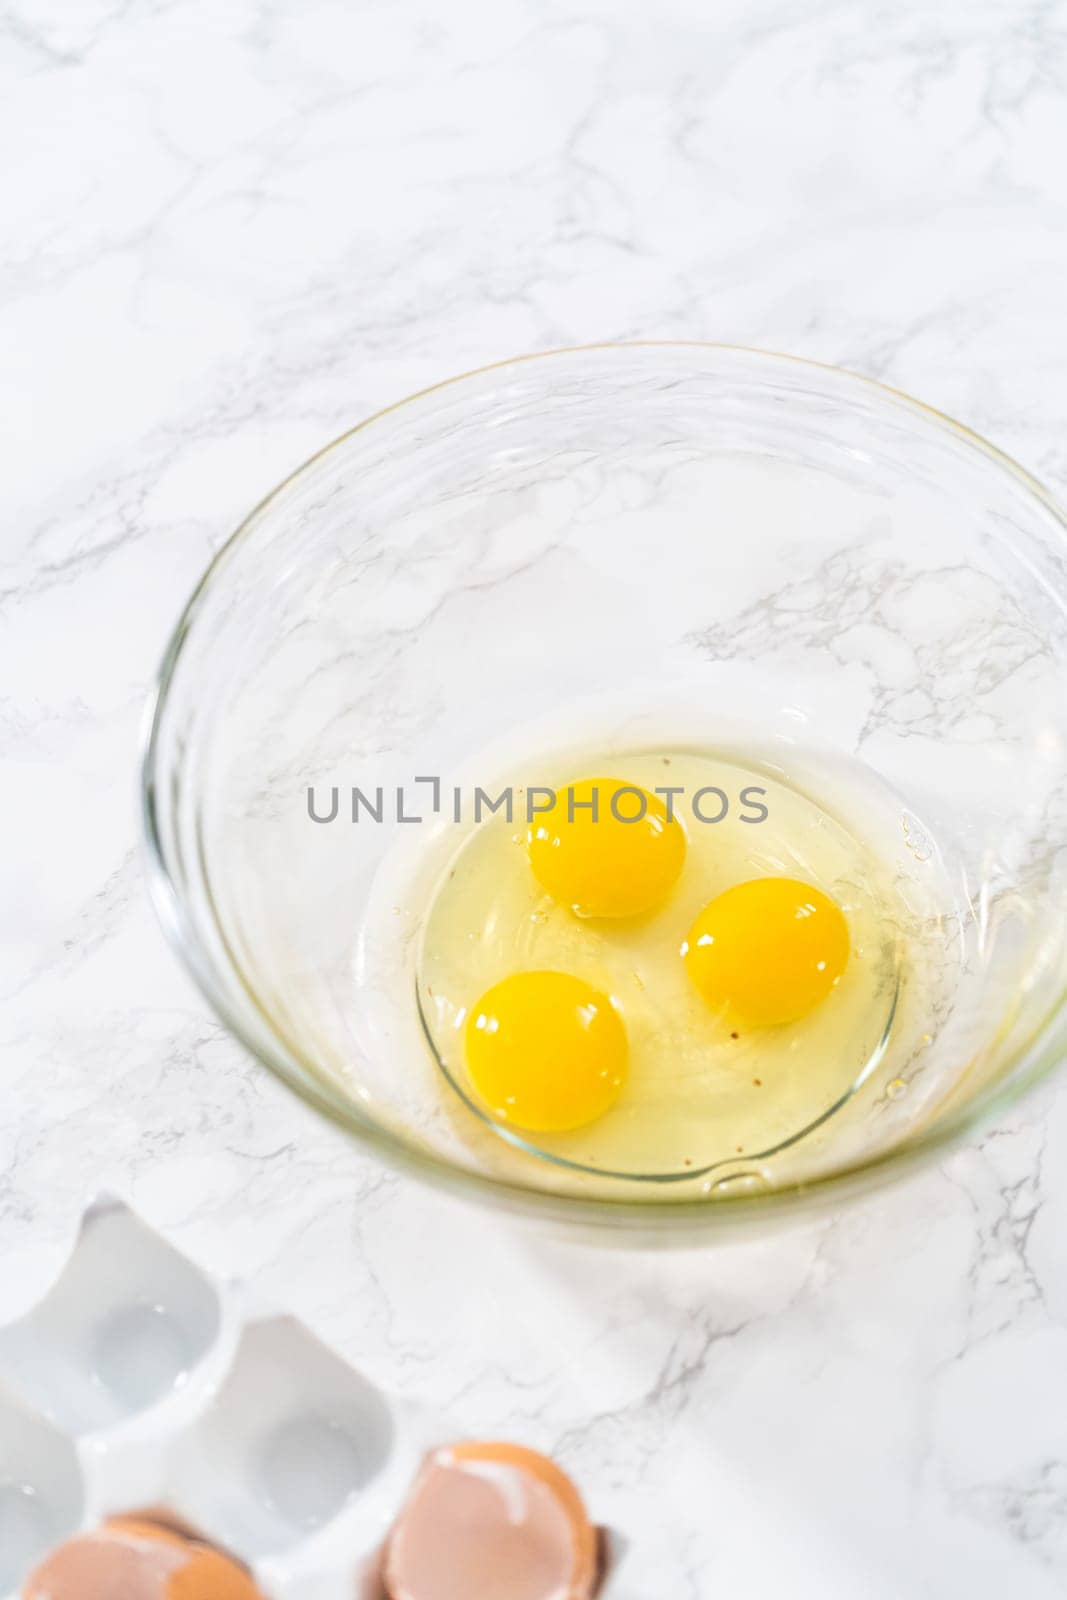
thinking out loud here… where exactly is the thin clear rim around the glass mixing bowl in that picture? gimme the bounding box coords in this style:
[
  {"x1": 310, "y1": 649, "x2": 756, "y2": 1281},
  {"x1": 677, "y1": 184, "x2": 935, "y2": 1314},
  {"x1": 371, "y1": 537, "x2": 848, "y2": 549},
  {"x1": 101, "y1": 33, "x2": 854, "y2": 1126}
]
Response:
[{"x1": 141, "y1": 339, "x2": 1067, "y2": 1243}]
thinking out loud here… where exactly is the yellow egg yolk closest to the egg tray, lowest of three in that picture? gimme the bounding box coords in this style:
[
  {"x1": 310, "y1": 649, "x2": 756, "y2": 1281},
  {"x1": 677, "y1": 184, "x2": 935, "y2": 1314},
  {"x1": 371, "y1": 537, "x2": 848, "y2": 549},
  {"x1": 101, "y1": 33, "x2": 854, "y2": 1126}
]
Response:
[{"x1": 464, "y1": 971, "x2": 629, "y2": 1133}]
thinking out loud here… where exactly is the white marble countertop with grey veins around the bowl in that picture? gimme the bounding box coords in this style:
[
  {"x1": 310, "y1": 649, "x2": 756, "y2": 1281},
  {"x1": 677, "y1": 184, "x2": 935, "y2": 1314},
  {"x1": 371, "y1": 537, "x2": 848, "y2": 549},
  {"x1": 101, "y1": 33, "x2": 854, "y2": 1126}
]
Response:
[{"x1": 0, "y1": 0, "x2": 1067, "y2": 1600}]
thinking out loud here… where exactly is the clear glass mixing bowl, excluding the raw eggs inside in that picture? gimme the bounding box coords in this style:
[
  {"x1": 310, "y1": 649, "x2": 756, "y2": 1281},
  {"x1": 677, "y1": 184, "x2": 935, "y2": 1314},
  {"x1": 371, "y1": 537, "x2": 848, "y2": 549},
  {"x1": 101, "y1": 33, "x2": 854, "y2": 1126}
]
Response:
[{"x1": 144, "y1": 344, "x2": 1067, "y2": 1237}]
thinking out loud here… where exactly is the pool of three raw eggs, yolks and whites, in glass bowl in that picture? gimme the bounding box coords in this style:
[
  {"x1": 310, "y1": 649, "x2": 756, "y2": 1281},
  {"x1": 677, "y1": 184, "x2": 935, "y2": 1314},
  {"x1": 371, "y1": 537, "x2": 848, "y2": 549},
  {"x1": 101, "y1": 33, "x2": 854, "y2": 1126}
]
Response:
[{"x1": 414, "y1": 747, "x2": 917, "y2": 1194}]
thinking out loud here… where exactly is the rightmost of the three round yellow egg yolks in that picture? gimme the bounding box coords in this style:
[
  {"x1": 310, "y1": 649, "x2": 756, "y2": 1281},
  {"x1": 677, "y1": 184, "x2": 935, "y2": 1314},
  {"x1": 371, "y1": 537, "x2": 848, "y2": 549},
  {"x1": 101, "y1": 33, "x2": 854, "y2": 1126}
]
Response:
[{"x1": 681, "y1": 878, "x2": 849, "y2": 1026}]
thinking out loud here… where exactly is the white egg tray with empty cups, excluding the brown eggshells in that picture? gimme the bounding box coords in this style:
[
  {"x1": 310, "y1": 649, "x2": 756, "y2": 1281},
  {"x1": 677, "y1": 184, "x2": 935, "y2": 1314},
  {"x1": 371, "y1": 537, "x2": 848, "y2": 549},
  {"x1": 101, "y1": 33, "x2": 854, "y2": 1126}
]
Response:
[{"x1": 0, "y1": 1197, "x2": 622, "y2": 1600}]
